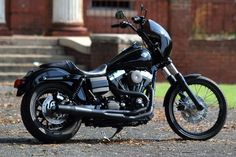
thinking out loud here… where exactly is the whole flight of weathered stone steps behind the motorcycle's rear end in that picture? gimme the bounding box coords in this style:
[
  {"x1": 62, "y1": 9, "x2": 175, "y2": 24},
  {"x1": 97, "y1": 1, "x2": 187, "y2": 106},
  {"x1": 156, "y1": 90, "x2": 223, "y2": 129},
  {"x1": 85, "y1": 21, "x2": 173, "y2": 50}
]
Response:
[{"x1": 0, "y1": 36, "x2": 87, "y2": 82}]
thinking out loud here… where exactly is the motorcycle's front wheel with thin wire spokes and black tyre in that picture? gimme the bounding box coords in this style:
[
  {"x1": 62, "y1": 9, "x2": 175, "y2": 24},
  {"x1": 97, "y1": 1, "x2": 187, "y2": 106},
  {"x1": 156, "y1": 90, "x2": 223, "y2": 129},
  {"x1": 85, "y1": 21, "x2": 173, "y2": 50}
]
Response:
[{"x1": 164, "y1": 76, "x2": 227, "y2": 140}]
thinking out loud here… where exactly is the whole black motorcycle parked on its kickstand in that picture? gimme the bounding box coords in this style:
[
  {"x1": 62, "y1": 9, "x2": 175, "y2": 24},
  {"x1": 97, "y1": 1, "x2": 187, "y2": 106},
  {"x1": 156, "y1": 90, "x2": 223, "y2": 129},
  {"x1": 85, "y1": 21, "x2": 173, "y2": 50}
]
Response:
[{"x1": 15, "y1": 7, "x2": 227, "y2": 143}]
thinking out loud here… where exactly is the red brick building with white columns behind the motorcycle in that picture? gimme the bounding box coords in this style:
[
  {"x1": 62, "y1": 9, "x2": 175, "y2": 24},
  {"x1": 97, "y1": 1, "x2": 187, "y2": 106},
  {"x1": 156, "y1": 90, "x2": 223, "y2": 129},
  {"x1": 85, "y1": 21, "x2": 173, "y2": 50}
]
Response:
[{"x1": 0, "y1": 0, "x2": 236, "y2": 83}]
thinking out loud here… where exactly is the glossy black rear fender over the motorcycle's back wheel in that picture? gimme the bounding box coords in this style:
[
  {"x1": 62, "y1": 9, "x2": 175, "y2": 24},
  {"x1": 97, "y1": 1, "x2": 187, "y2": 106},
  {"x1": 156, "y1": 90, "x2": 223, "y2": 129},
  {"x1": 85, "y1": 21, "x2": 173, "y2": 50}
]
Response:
[{"x1": 16, "y1": 68, "x2": 72, "y2": 96}]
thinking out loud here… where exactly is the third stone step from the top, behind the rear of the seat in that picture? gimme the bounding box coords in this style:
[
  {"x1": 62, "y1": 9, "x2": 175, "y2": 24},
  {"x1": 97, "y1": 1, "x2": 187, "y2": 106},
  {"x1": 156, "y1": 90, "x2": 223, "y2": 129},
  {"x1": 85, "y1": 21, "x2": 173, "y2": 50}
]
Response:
[{"x1": 0, "y1": 54, "x2": 74, "y2": 64}]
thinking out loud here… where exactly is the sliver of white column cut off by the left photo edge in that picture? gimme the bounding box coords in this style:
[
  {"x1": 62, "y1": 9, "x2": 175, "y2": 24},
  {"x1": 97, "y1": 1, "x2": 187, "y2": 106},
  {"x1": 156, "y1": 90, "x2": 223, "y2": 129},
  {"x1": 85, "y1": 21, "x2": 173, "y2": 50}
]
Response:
[{"x1": 0, "y1": 0, "x2": 10, "y2": 36}]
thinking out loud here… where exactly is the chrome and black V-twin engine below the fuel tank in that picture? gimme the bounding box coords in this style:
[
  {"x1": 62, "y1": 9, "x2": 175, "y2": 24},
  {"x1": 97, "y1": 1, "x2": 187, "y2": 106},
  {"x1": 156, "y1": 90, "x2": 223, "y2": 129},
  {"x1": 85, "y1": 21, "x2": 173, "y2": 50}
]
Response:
[{"x1": 103, "y1": 70, "x2": 153, "y2": 110}]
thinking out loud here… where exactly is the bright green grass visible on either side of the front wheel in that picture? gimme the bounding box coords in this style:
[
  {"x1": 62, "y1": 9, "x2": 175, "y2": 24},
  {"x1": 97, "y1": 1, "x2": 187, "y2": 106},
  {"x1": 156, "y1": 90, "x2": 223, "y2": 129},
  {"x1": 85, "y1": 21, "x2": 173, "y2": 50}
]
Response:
[{"x1": 156, "y1": 83, "x2": 236, "y2": 109}]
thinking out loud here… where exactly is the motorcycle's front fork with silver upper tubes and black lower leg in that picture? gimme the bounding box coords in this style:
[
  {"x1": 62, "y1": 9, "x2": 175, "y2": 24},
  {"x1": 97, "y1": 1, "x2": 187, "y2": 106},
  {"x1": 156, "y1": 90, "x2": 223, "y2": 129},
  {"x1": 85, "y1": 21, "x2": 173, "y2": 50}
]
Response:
[{"x1": 162, "y1": 62, "x2": 204, "y2": 111}]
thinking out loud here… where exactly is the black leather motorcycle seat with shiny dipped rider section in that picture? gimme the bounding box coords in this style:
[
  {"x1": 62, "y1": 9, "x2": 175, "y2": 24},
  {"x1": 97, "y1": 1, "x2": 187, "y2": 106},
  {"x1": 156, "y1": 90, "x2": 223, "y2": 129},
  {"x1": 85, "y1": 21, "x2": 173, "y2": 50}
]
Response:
[{"x1": 39, "y1": 60, "x2": 107, "y2": 76}]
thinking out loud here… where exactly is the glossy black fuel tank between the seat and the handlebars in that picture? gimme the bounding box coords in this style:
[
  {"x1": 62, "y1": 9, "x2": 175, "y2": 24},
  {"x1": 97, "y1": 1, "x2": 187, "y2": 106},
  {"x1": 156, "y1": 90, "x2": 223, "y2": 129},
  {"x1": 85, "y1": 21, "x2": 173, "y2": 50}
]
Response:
[{"x1": 107, "y1": 43, "x2": 152, "y2": 71}]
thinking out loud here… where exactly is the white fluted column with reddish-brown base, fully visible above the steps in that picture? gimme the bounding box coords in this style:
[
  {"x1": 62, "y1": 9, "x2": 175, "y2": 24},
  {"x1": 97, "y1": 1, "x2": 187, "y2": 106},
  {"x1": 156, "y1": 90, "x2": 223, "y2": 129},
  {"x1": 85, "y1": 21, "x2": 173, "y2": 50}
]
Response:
[{"x1": 52, "y1": 0, "x2": 88, "y2": 36}]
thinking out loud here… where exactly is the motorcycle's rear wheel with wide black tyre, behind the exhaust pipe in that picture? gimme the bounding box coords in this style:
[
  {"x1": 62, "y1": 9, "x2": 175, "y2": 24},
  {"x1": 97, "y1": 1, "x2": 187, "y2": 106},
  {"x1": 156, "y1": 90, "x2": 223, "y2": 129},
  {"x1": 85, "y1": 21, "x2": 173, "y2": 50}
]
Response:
[{"x1": 21, "y1": 83, "x2": 81, "y2": 143}]
